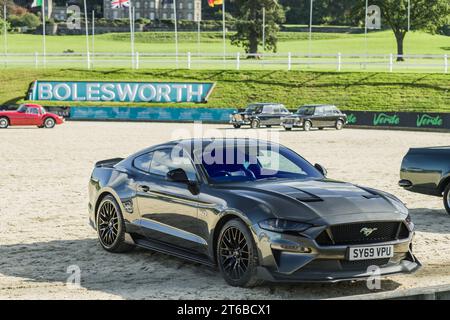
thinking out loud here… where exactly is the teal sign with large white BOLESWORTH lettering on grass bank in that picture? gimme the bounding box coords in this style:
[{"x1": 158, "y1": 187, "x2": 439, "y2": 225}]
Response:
[{"x1": 28, "y1": 80, "x2": 214, "y2": 103}]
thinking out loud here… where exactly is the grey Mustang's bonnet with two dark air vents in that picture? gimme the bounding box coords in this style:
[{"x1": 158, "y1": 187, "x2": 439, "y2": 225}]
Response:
[{"x1": 221, "y1": 179, "x2": 405, "y2": 223}]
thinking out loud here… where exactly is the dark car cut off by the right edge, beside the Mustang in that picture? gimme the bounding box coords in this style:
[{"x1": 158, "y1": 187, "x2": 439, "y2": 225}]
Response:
[{"x1": 399, "y1": 146, "x2": 450, "y2": 214}]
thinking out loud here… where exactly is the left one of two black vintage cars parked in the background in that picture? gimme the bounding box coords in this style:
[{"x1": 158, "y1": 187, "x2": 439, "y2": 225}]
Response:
[{"x1": 230, "y1": 103, "x2": 291, "y2": 128}]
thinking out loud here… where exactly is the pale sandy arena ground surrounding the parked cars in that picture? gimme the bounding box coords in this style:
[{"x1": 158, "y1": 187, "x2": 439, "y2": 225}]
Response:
[{"x1": 0, "y1": 122, "x2": 450, "y2": 299}]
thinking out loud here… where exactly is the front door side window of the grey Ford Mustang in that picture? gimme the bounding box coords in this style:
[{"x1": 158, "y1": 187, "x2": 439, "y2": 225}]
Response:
[{"x1": 150, "y1": 149, "x2": 197, "y2": 181}]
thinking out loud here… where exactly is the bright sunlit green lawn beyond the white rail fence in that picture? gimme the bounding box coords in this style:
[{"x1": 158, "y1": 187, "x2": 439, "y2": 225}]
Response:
[{"x1": 0, "y1": 31, "x2": 450, "y2": 54}]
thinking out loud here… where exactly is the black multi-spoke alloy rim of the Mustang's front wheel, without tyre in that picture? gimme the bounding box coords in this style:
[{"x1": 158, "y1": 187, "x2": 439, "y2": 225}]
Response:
[{"x1": 220, "y1": 227, "x2": 250, "y2": 280}]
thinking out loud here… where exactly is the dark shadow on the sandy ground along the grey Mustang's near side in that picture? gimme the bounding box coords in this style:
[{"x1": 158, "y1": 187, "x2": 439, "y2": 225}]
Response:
[{"x1": 0, "y1": 239, "x2": 399, "y2": 299}]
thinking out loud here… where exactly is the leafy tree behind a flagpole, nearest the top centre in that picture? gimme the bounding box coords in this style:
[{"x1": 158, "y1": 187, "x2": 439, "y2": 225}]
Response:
[{"x1": 231, "y1": 0, "x2": 285, "y2": 57}]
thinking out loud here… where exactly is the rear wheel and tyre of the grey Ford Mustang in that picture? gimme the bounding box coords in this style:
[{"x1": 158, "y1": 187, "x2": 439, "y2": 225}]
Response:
[{"x1": 96, "y1": 195, "x2": 134, "y2": 253}]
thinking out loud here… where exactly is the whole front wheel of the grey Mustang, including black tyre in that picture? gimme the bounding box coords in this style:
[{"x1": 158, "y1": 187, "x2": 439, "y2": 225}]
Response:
[{"x1": 216, "y1": 219, "x2": 262, "y2": 288}]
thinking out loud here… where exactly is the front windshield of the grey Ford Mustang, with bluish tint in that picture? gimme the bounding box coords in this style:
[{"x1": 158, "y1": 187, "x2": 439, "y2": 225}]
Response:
[{"x1": 197, "y1": 142, "x2": 323, "y2": 183}]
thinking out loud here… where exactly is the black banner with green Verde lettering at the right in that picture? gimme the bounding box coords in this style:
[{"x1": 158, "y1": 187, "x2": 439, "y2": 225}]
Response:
[{"x1": 343, "y1": 110, "x2": 450, "y2": 130}]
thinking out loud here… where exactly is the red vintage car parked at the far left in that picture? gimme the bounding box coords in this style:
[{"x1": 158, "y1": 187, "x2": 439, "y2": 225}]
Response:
[{"x1": 0, "y1": 104, "x2": 64, "y2": 129}]
